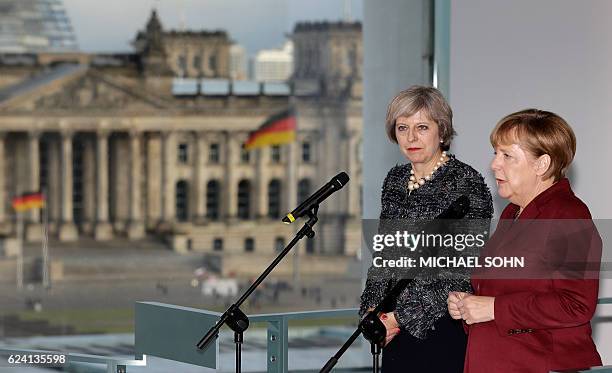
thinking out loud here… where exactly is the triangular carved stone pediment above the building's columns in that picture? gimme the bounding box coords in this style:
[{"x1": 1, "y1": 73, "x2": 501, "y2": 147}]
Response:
[{"x1": 0, "y1": 64, "x2": 168, "y2": 114}]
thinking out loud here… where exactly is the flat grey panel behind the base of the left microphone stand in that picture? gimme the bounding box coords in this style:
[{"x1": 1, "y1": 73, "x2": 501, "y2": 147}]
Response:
[{"x1": 135, "y1": 302, "x2": 221, "y2": 369}]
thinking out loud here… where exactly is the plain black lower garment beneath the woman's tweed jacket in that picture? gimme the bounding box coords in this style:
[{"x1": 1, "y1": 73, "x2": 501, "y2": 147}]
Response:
[{"x1": 382, "y1": 314, "x2": 467, "y2": 373}]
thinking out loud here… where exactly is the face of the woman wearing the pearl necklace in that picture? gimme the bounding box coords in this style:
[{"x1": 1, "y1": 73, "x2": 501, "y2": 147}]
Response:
[{"x1": 395, "y1": 110, "x2": 440, "y2": 164}]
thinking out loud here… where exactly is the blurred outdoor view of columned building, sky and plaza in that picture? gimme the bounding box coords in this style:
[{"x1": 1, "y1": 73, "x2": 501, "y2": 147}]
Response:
[{"x1": 0, "y1": 0, "x2": 363, "y2": 370}]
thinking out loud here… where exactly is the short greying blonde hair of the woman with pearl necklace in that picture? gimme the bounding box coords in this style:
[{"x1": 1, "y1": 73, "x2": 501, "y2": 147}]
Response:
[{"x1": 385, "y1": 85, "x2": 456, "y2": 150}]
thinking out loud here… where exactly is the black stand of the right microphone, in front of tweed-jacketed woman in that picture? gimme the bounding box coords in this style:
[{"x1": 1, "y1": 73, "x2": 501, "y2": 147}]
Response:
[{"x1": 319, "y1": 279, "x2": 410, "y2": 373}]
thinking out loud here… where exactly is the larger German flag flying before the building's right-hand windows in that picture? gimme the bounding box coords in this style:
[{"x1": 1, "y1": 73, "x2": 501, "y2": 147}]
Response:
[{"x1": 244, "y1": 109, "x2": 296, "y2": 150}]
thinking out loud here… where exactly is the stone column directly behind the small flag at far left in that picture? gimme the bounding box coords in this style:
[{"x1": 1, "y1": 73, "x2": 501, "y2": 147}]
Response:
[{"x1": 25, "y1": 131, "x2": 46, "y2": 242}]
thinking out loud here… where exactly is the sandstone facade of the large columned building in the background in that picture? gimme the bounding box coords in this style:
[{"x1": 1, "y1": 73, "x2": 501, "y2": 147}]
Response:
[{"x1": 0, "y1": 14, "x2": 362, "y2": 254}]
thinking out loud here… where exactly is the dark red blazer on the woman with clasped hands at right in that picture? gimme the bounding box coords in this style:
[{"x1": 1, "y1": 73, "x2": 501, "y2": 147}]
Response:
[{"x1": 464, "y1": 178, "x2": 601, "y2": 373}]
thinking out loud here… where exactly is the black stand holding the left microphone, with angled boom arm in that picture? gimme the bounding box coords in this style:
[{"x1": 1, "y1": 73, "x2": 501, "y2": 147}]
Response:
[{"x1": 197, "y1": 205, "x2": 320, "y2": 373}]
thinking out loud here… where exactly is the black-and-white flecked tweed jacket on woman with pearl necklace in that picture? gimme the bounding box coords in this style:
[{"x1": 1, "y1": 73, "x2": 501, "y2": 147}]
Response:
[{"x1": 360, "y1": 155, "x2": 493, "y2": 339}]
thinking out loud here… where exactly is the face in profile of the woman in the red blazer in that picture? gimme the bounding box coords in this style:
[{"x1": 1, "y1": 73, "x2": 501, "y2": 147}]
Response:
[{"x1": 491, "y1": 144, "x2": 540, "y2": 207}]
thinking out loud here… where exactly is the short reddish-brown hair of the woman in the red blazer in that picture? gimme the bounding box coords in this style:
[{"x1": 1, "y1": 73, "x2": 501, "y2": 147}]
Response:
[{"x1": 490, "y1": 109, "x2": 576, "y2": 181}]
